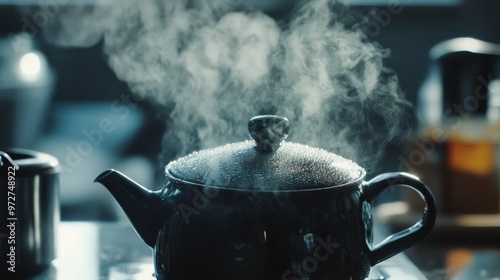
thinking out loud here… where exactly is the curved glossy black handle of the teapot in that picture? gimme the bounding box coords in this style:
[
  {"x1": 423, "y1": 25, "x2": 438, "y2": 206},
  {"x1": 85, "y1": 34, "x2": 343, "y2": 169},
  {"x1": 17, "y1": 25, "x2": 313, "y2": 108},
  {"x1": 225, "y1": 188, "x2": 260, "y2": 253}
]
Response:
[{"x1": 361, "y1": 172, "x2": 436, "y2": 266}]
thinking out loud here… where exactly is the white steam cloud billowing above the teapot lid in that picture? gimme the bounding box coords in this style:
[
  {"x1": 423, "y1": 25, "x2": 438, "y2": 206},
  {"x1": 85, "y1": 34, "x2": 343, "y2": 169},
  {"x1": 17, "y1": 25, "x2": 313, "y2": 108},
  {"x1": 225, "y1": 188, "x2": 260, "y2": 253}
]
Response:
[{"x1": 42, "y1": 0, "x2": 409, "y2": 172}]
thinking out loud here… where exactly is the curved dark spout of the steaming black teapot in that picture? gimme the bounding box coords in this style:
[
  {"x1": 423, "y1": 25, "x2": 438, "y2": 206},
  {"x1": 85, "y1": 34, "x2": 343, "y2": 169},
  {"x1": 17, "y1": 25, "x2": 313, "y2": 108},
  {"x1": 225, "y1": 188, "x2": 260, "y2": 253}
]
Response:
[{"x1": 94, "y1": 169, "x2": 168, "y2": 247}]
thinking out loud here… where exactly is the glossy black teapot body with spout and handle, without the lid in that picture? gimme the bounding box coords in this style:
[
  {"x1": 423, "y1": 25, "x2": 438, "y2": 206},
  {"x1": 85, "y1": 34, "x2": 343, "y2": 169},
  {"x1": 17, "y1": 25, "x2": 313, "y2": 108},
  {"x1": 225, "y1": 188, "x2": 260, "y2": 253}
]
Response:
[{"x1": 97, "y1": 171, "x2": 436, "y2": 280}]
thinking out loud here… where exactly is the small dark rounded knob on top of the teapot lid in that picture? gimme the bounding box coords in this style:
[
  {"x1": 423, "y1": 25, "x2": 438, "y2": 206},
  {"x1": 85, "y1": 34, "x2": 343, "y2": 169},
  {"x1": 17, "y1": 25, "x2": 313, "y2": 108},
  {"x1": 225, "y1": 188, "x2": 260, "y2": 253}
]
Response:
[{"x1": 248, "y1": 115, "x2": 290, "y2": 153}]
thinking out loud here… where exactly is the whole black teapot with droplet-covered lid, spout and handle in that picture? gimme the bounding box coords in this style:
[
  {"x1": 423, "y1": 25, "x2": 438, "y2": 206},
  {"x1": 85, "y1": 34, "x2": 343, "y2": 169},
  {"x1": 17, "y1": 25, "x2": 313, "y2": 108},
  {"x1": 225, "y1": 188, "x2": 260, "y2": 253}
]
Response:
[{"x1": 96, "y1": 116, "x2": 436, "y2": 280}]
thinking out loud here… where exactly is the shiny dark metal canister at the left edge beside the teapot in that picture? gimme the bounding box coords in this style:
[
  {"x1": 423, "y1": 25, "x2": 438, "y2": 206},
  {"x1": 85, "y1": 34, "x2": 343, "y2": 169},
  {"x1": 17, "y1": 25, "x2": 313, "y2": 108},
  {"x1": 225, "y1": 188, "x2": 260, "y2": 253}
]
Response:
[{"x1": 0, "y1": 149, "x2": 61, "y2": 279}]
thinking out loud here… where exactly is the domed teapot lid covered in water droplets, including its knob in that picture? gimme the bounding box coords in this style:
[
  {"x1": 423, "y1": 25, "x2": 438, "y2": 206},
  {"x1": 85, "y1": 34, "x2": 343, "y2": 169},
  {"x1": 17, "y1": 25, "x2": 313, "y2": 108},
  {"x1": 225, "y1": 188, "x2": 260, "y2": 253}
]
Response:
[{"x1": 165, "y1": 115, "x2": 366, "y2": 192}]
